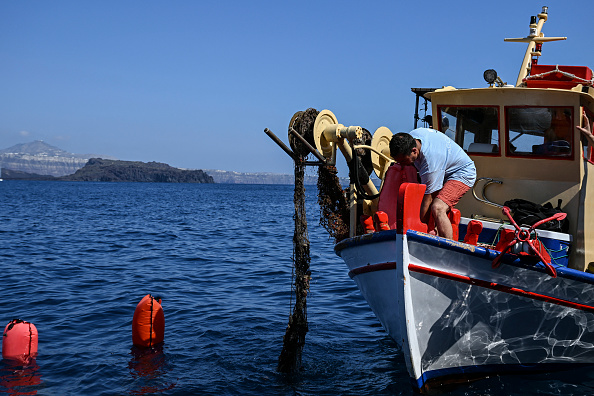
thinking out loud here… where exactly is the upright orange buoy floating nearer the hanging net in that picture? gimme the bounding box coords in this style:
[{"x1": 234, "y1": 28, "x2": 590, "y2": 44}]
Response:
[{"x1": 132, "y1": 294, "x2": 165, "y2": 347}]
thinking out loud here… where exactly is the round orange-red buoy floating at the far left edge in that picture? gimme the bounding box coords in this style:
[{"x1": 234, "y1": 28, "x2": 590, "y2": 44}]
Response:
[{"x1": 2, "y1": 319, "x2": 37, "y2": 363}]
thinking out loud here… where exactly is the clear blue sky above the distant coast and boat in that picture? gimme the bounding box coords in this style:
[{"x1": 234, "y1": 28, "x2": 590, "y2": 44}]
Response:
[{"x1": 0, "y1": 0, "x2": 594, "y2": 173}]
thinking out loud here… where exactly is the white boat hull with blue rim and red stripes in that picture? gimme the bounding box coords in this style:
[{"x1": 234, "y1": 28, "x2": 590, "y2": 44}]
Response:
[{"x1": 336, "y1": 231, "x2": 594, "y2": 388}]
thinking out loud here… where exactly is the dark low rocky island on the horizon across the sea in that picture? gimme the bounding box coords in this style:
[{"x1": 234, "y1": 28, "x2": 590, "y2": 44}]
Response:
[{"x1": 59, "y1": 158, "x2": 214, "y2": 183}]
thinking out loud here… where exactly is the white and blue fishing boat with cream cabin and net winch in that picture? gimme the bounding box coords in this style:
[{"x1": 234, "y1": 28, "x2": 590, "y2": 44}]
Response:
[{"x1": 266, "y1": 7, "x2": 594, "y2": 391}]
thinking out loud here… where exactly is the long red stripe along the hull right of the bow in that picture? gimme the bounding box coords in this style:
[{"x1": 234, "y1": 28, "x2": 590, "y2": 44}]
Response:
[{"x1": 408, "y1": 264, "x2": 594, "y2": 313}]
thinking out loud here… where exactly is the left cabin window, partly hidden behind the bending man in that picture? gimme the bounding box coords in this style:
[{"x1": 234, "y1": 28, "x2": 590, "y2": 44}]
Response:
[{"x1": 438, "y1": 106, "x2": 499, "y2": 155}]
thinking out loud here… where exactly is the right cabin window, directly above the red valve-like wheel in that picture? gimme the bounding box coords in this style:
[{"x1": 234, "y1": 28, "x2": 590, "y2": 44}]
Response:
[{"x1": 505, "y1": 107, "x2": 574, "y2": 157}]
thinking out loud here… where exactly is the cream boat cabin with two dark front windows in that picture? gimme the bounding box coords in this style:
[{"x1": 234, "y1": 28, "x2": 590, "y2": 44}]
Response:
[{"x1": 425, "y1": 74, "x2": 594, "y2": 270}]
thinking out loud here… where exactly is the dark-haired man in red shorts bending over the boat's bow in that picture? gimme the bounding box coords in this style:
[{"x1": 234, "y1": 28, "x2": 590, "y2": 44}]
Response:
[{"x1": 390, "y1": 128, "x2": 476, "y2": 239}]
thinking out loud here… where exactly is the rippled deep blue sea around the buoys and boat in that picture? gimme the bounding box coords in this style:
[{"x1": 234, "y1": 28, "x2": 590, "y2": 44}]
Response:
[{"x1": 0, "y1": 181, "x2": 594, "y2": 395}]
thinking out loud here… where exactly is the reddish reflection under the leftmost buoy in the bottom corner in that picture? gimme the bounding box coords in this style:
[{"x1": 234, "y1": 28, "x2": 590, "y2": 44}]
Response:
[{"x1": 0, "y1": 359, "x2": 42, "y2": 395}]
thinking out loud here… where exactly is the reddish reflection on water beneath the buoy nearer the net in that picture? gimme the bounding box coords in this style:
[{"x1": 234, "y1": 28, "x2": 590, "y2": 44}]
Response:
[{"x1": 128, "y1": 343, "x2": 175, "y2": 395}]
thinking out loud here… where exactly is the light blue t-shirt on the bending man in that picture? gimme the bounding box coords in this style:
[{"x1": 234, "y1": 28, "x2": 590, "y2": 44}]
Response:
[{"x1": 409, "y1": 128, "x2": 476, "y2": 194}]
